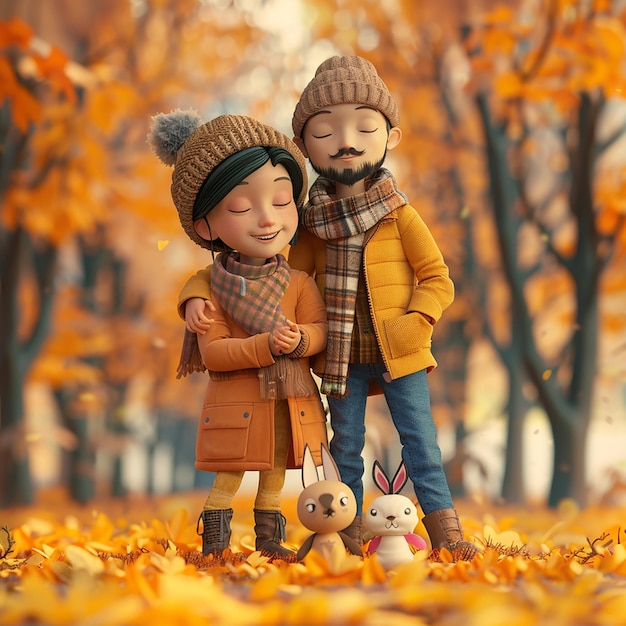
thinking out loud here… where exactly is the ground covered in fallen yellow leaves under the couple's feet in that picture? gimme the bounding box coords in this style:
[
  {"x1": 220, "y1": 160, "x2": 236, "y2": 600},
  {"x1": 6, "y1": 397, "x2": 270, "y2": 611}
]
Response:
[{"x1": 0, "y1": 494, "x2": 626, "y2": 626}]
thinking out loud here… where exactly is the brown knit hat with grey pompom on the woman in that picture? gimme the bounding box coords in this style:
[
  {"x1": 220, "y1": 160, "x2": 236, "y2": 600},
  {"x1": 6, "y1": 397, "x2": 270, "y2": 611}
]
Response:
[{"x1": 148, "y1": 109, "x2": 307, "y2": 248}]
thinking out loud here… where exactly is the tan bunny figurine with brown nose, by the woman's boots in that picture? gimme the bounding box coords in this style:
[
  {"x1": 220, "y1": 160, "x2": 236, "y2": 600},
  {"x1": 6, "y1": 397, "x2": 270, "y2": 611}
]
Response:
[{"x1": 297, "y1": 444, "x2": 363, "y2": 561}]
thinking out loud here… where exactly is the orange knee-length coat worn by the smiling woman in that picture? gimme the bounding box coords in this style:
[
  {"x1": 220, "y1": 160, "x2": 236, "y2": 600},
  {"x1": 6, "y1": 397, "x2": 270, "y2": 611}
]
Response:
[{"x1": 195, "y1": 270, "x2": 328, "y2": 471}]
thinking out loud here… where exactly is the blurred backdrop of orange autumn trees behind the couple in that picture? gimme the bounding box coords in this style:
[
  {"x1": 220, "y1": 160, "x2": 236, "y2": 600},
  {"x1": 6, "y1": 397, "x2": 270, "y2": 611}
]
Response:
[{"x1": 0, "y1": 0, "x2": 626, "y2": 507}]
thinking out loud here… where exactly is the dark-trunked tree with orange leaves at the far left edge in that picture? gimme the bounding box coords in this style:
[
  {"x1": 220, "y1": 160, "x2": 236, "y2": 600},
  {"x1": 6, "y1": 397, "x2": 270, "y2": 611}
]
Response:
[{"x1": 0, "y1": 20, "x2": 85, "y2": 504}]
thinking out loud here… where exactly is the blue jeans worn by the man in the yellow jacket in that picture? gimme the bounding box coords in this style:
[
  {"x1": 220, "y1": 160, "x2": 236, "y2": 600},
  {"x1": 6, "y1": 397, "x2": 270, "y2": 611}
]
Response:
[{"x1": 328, "y1": 363, "x2": 453, "y2": 515}]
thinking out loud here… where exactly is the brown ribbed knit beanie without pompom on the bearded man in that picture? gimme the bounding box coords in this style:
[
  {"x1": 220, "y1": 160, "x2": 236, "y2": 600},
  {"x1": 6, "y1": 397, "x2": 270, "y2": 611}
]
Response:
[{"x1": 291, "y1": 56, "x2": 400, "y2": 137}]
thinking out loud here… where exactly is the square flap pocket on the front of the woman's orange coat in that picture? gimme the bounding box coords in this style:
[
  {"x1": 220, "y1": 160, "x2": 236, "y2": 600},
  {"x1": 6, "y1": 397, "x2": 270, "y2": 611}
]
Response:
[{"x1": 197, "y1": 403, "x2": 254, "y2": 461}]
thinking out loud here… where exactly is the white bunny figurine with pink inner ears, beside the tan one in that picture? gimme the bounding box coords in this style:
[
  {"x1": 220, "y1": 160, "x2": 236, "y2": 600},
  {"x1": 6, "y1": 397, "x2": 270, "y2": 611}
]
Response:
[{"x1": 365, "y1": 461, "x2": 426, "y2": 570}]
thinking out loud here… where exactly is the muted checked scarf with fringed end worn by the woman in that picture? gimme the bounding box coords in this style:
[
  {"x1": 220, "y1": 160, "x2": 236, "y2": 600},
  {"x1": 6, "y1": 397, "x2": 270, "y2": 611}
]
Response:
[{"x1": 211, "y1": 252, "x2": 312, "y2": 400}]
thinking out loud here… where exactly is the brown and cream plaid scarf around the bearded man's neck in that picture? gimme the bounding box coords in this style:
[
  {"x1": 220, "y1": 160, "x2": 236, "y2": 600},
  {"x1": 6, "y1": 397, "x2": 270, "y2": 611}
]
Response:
[{"x1": 302, "y1": 168, "x2": 408, "y2": 397}]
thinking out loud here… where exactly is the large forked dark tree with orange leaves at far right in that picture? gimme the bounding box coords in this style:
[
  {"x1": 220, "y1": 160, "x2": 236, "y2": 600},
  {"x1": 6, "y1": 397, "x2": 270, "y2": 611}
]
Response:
[{"x1": 466, "y1": 2, "x2": 626, "y2": 505}]
